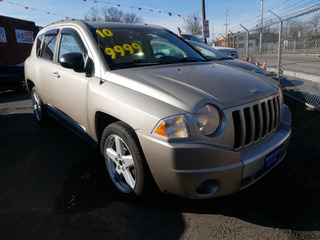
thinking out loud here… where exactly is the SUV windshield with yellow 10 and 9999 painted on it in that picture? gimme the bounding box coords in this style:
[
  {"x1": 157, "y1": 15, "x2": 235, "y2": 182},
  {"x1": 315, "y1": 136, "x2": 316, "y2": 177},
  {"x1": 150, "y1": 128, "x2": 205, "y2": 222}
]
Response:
[{"x1": 87, "y1": 23, "x2": 205, "y2": 70}]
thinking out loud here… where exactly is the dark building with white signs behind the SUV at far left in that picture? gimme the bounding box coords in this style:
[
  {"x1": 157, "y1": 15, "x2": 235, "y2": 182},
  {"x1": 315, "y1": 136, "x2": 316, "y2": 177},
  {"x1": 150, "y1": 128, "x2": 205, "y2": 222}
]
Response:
[{"x1": 0, "y1": 15, "x2": 39, "y2": 65}]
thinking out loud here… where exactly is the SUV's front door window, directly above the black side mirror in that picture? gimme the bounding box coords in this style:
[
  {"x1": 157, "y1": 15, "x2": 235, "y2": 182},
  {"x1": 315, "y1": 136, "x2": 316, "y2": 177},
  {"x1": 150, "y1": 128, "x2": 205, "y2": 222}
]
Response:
[{"x1": 58, "y1": 30, "x2": 87, "y2": 61}]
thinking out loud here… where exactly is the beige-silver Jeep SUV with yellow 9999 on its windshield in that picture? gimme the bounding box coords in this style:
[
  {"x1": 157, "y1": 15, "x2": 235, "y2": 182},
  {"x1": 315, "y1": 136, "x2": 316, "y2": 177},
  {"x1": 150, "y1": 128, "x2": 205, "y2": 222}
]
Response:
[{"x1": 25, "y1": 20, "x2": 291, "y2": 198}]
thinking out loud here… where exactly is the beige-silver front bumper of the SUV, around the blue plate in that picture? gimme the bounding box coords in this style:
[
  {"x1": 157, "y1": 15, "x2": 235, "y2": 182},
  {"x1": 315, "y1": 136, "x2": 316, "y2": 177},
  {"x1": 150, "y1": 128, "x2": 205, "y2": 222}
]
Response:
[{"x1": 137, "y1": 108, "x2": 291, "y2": 199}]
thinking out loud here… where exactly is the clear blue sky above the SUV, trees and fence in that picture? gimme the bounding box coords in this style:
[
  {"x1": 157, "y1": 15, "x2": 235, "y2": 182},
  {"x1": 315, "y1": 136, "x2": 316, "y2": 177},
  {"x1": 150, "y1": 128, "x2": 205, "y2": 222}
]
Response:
[{"x1": 0, "y1": 0, "x2": 319, "y2": 38}]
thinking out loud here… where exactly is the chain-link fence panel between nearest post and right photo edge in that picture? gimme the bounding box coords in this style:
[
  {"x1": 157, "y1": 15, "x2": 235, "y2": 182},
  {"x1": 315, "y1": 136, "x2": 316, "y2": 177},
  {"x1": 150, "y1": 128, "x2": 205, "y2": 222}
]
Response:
[{"x1": 280, "y1": 11, "x2": 320, "y2": 109}]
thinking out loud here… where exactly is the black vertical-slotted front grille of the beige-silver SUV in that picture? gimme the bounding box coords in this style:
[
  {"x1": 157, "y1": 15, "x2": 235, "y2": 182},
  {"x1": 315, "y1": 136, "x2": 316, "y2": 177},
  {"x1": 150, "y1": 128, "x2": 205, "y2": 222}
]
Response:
[{"x1": 232, "y1": 96, "x2": 281, "y2": 149}]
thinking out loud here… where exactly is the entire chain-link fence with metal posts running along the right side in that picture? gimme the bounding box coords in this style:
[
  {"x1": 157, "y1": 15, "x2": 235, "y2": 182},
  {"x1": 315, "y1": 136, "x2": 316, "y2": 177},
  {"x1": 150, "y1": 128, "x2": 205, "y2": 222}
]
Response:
[{"x1": 228, "y1": 7, "x2": 320, "y2": 110}]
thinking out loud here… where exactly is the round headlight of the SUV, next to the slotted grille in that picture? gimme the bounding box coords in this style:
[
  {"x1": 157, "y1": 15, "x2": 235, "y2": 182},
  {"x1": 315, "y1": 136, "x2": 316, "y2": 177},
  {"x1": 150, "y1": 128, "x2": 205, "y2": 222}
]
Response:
[{"x1": 197, "y1": 104, "x2": 220, "y2": 135}]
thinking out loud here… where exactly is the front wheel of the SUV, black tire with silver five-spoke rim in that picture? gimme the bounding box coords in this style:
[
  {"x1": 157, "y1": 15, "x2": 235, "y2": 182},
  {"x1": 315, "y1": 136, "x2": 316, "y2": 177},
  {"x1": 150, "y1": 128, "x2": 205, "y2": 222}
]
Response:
[{"x1": 100, "y1": 122, "x2": 147, "y2": 200}]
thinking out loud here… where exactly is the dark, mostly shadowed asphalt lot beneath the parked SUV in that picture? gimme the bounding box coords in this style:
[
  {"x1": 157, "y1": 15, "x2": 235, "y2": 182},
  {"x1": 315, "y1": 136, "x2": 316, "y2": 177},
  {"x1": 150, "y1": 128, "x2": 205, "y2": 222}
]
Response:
[{"x1": 0, "y1": 92, "x2": 320, "y2": 240}]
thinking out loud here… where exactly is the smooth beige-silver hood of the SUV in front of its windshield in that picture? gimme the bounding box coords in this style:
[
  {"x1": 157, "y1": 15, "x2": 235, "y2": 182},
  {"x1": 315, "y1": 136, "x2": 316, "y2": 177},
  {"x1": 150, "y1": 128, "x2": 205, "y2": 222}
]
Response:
[{"x1": 108, "y1": 63, "x2": 277, "y2": 113}]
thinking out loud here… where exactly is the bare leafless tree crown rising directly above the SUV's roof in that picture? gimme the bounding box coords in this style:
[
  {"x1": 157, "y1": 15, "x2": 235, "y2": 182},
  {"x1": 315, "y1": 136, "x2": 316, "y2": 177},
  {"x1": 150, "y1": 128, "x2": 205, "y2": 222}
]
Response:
[{"x1": 84, "y1": 7, "x2": 143, "y2": 23}]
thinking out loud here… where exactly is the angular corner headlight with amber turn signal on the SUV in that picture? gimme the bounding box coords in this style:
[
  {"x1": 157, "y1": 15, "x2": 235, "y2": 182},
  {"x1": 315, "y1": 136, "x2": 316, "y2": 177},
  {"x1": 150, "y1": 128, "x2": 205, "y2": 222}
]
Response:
[{"x1": 155, "y1": 116, "x2": 189, "y2": 138}]
